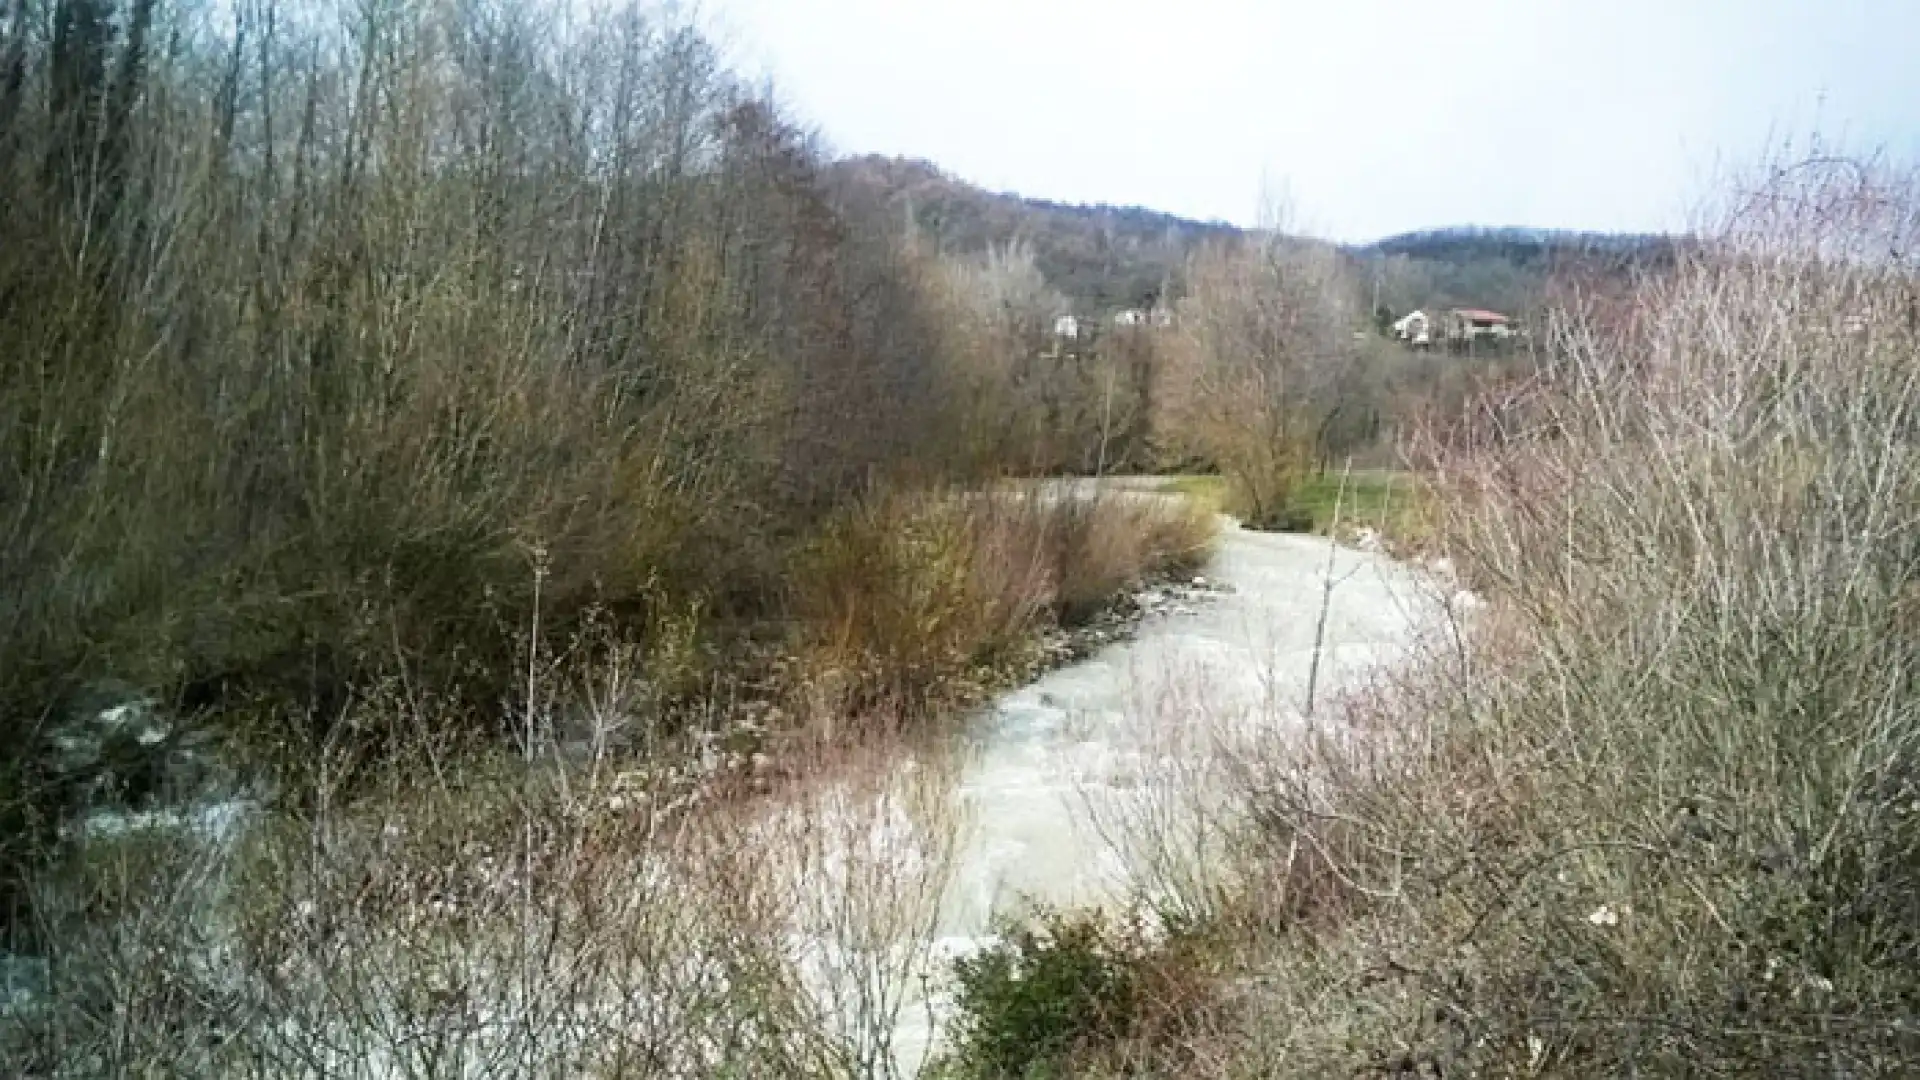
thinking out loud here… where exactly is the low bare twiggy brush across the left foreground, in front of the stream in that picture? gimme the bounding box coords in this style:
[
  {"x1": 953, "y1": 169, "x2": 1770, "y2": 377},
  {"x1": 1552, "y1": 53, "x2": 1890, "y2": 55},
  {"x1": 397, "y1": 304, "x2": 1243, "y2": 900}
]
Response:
[{"x1": 0, "y1": 657, "x2": 975, "y2": 1078}]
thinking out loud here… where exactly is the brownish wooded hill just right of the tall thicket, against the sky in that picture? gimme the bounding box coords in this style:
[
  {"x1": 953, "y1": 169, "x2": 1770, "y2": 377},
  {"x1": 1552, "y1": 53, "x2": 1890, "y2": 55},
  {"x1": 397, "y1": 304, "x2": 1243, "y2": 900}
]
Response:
[{"x1": 828, "y1": 156, "x2": 1240, "y2": 313}]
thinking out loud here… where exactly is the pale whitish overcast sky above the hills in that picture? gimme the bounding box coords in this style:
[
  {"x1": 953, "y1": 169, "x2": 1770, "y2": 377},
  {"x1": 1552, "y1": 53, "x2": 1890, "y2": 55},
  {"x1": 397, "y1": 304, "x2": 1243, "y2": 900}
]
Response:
[{"x1": 707, "y1": 0, "x2": 1920, "y2": 240}]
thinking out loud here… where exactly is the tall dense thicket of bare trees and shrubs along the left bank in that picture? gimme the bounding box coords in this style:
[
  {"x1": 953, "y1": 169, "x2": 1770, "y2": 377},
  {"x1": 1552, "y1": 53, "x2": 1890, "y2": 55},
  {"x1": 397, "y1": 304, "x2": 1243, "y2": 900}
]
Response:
[{"x1": 0, "y1": 0, "x2": 1206, "y2": 926}]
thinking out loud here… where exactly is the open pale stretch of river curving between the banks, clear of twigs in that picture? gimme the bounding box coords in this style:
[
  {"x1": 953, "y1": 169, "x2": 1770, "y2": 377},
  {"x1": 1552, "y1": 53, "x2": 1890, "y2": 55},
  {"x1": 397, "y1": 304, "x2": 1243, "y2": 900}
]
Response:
[{"x1": 895, "y1": 511, "x2": 1448, "y2": 1074}]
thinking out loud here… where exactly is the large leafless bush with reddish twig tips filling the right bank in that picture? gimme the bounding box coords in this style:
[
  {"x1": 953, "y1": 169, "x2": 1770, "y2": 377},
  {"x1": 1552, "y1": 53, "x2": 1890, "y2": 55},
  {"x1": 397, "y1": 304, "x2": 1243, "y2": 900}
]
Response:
[{"x1": 1113, "y1": 160, "x2": 1920, "y2": 1076}]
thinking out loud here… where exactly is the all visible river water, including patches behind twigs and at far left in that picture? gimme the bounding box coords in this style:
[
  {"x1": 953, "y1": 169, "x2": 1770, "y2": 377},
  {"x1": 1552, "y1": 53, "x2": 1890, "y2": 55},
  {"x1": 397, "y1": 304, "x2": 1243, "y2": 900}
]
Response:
[{"x1": 0, "y1": 488, "x2": 1448, "y2": 1076}]
